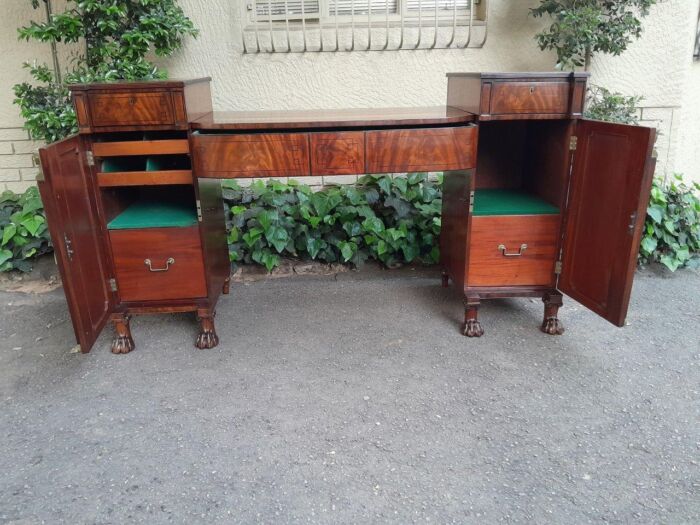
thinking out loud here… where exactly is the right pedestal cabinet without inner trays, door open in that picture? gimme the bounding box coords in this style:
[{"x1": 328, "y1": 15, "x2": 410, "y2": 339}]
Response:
[{"x1": 440, "y1": 73, "x2": 655, "y2": 337}]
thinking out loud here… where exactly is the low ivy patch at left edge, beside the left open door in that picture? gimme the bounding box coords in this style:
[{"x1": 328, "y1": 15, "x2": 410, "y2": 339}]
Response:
[{"x1": 0, "y1": 187, "x2": 51, "y2": 272}]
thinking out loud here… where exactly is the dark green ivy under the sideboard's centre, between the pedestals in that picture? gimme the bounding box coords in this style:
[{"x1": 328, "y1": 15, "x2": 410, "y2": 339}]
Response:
[{"x1": 224, "y1": 173, "x2": 442, "y2": 271}]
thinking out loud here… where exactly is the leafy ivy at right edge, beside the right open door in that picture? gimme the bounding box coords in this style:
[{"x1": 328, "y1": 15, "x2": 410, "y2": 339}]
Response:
[{"x1": 639, "y1": 174, "x2": 700, "y2": 271}]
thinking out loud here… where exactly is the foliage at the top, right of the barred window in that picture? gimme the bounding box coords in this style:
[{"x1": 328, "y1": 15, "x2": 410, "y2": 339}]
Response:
[{"x1": 530, "y1": 0, "x2": 657, "y2": 70}]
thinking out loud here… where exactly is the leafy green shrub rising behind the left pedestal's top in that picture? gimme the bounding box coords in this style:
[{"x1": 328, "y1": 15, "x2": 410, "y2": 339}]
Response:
[{"x1": 14, "y1": 0, "x2": 197, "y2": 142}]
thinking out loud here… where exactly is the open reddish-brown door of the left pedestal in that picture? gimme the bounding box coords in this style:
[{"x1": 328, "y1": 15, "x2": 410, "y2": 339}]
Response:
[{"x1": 39, "y1": 136, "x2": 113, "y2": 352}]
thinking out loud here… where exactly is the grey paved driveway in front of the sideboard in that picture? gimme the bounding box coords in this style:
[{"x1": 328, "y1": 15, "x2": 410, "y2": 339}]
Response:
[{"x1": 0, "y1": 269, "x2": 700, "y2": 525}]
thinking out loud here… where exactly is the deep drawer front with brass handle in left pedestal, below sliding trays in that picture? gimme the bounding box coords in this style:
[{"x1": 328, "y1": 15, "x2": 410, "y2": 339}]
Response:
[{"x1": 109, "y1": 226, "x2": 207, "y2": 301}]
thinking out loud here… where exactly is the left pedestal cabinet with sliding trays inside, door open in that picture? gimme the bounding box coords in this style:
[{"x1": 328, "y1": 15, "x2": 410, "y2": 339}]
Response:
[{"x1": 39, "y1": 78, "x2": 229, "y2": 353}]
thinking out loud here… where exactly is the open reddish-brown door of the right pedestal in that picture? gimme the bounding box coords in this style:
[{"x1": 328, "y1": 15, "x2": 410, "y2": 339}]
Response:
[{"x1": 558, "y1": 120, "x2": 655, "y2": 326}]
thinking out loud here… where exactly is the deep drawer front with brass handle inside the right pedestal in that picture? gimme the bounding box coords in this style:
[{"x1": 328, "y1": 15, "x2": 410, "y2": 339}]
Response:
[{"x1": 467, "y1": 215, "x2": 561, "y2": 287}]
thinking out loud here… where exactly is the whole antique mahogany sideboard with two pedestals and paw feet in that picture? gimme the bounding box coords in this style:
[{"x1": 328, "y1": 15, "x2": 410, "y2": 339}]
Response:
[{"x1": 39, "y1": 73, "x2": 654, "y2": 353}]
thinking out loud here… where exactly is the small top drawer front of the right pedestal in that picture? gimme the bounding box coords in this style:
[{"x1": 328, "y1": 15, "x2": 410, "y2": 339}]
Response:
[{"x1": 491, "y1": 82, "x2": 570, "y2": 115}]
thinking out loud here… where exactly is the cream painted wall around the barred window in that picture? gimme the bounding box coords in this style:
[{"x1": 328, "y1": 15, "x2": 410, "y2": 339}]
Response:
[{"x1": 0, "y1": 0, "x2": 700, "y2": 189}]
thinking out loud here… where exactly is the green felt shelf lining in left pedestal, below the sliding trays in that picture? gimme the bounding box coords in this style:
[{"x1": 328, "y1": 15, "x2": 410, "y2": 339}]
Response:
[{"x1": 107, "y1": 201, "x2": 197, "y2": 230}]
